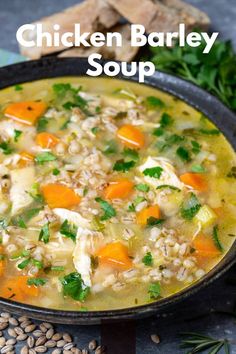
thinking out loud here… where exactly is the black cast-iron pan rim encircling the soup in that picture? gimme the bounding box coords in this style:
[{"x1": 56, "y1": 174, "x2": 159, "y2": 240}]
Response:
[{"x1": 0, "y1": 58, "x2": 236, "y2": 325}]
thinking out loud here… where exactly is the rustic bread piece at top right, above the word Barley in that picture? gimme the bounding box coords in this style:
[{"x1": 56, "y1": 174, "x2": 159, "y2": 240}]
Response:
[{"x1": 107, "y1": 0, "x2": 210, "y2": 33}]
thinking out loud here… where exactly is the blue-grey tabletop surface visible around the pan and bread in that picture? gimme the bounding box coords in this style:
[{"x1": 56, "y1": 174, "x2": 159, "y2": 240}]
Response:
[{"x1": 0, "y1": 0, "x2": 236, "y2": 354}]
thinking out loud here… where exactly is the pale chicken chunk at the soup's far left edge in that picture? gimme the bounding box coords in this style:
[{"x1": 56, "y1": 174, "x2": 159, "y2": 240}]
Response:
[{"x1": 10, "y1": 167, "x2": 35, "y2": 215}]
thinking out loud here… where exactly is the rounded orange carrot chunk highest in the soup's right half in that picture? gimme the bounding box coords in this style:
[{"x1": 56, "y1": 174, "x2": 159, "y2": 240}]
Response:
[{"x1": 117, "y1": 124, "x2": 145, "y2": 149}]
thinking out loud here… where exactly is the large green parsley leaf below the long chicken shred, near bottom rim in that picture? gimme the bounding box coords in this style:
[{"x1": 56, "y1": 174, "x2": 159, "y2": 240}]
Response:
[{"x1": 60, "y1": 272, "x2": 90, "y2": 301}]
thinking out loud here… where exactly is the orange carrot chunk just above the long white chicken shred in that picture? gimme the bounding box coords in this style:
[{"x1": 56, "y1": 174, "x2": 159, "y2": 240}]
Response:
[{"x1": 41, "y1": 183, "x2": 81, "y2": 209}]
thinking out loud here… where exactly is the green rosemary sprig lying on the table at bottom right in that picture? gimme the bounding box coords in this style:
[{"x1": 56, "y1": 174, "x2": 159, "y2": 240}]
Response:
[{"x1": 181, "y1": 332, "x2": 230, "y2": 354}]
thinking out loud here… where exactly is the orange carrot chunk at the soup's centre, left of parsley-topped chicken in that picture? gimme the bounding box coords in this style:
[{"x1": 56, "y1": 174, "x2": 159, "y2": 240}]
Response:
[{"x1": 104, "y1": 178, "x2": 134, "y2": 199}]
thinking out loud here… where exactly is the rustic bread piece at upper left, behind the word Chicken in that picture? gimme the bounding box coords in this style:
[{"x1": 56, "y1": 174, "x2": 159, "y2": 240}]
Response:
[{"x1": 20, "y1": 0, "x2": 120, "y2": 59}]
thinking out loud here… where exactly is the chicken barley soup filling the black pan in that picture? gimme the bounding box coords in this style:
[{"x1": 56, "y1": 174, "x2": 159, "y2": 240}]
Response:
[{"x1": 0, "y1": 77, "x2": 236, "y2": 311}]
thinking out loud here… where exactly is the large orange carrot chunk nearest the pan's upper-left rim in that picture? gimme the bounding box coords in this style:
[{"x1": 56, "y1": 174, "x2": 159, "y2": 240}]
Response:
[{"x1": 4, "y1": 101, "x2": 47, "y2": 125}]
